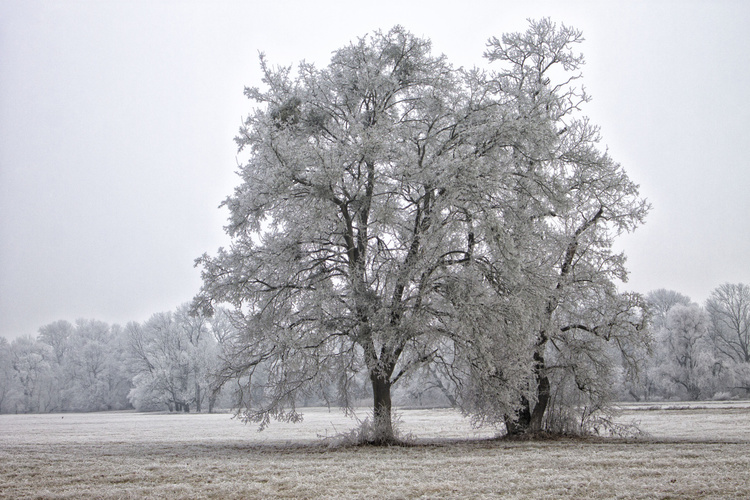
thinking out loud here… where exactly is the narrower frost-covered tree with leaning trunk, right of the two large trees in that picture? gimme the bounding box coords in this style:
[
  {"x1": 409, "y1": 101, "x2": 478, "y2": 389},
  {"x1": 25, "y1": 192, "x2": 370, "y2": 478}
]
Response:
[{"x1": 440, "y1": 19, "x2": 649, "y2": 433}]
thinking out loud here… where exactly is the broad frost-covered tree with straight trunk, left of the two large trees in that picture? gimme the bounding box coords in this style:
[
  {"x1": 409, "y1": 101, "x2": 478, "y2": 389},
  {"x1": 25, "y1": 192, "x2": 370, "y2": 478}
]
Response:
[{"x1": 197, "y1": 28, "x2": 524, "y2": 442}]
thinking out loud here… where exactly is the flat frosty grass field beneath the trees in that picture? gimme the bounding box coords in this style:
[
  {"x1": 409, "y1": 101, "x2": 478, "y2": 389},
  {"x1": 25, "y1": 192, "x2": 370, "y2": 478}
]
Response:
[{"x1": 0, "y1": 402, "x2": 750, "y2": 498}]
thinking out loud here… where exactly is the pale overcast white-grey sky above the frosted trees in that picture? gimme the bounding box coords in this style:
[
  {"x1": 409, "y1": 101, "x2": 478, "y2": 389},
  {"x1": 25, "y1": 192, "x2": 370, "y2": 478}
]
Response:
[{"x1": 0, "y1": 0, "x2": 750, "y2": 338}]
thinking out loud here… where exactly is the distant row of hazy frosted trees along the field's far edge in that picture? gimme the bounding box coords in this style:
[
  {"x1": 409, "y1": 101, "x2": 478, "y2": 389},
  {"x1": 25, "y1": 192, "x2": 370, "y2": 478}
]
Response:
[{"x1": 0, "y1": 284, "x2": 750, "y2": 413}]
